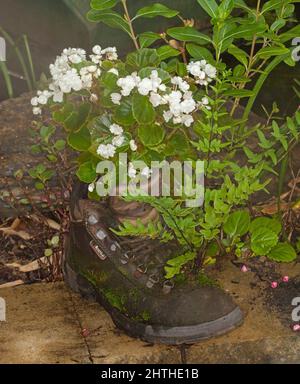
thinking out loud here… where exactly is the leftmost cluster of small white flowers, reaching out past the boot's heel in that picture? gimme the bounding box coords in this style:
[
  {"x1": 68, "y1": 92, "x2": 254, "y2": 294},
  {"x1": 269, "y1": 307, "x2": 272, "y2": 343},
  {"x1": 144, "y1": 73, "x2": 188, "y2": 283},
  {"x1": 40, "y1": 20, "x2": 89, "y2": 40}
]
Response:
[{"x1": 31, "y1": 46, "x2": 118, "y2": 115}]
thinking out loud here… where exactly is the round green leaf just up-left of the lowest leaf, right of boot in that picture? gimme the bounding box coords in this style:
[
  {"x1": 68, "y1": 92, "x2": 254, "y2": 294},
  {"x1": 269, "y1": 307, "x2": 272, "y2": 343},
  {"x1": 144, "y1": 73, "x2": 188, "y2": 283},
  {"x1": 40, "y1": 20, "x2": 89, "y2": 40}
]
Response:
[{"x1": 251, "y1": 228, "x2": 278, "y2": 256}]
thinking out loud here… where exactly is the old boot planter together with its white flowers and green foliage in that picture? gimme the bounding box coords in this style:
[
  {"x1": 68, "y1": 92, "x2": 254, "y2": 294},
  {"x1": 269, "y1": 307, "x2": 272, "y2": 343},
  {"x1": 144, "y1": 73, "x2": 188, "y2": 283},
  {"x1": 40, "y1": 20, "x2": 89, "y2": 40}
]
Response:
[{"x1": 32, "y1": 0, "x2": 300, "y2": 343}]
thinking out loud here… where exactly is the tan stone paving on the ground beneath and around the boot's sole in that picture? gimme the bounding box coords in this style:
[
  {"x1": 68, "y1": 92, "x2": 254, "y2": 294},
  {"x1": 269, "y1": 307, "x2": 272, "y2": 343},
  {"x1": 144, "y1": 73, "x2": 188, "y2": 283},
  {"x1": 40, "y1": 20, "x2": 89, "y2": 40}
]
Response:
[{"x1": 0, "y1": 260, "x2": 300, "y2": 363}]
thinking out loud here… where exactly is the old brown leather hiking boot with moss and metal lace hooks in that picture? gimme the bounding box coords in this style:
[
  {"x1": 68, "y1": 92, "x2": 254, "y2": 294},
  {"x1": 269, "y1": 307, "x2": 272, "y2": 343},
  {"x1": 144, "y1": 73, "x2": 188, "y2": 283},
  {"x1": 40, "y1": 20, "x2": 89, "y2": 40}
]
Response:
[{"x1": 64, "y1": 184, "x2": 243, "y2": 344}]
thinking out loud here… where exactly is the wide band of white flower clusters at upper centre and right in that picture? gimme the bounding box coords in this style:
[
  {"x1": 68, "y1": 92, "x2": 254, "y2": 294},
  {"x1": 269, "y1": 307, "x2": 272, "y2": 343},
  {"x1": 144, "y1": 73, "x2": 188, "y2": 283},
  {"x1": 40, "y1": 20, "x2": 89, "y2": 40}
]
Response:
[{"x1": 111, "y1": 66, "x2": 217, "y2": 127}]
